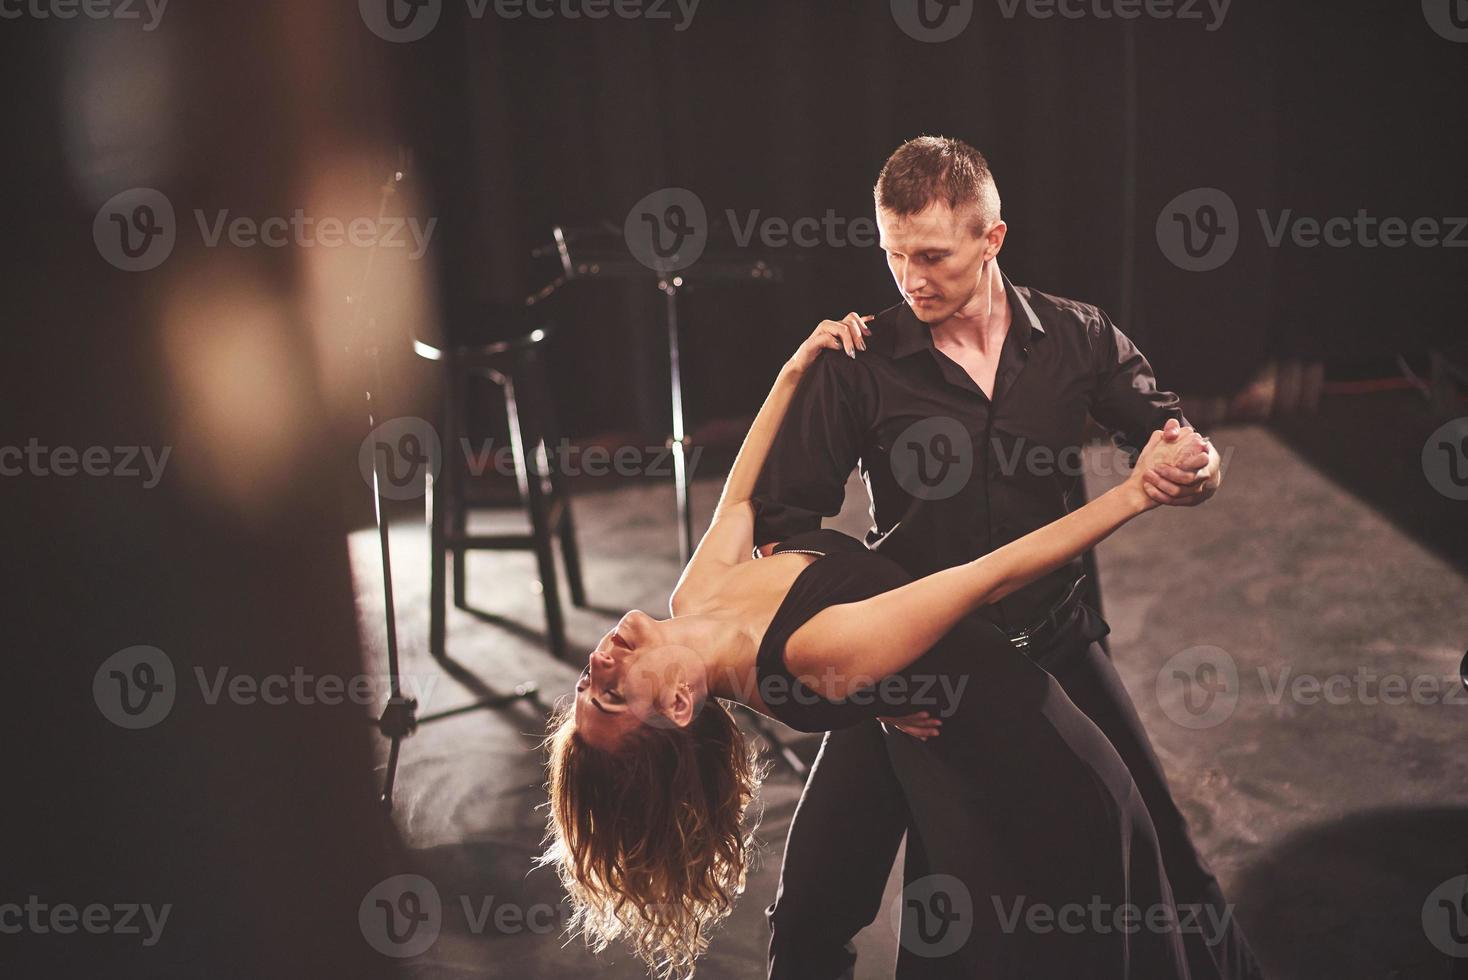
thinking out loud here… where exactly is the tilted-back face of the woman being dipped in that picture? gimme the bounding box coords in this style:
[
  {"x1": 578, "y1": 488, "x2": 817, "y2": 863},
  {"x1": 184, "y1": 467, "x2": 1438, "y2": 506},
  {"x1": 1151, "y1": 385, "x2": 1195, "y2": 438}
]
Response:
[{"x1": 575, "y1": 609, "x2": 694, "y2": 748}]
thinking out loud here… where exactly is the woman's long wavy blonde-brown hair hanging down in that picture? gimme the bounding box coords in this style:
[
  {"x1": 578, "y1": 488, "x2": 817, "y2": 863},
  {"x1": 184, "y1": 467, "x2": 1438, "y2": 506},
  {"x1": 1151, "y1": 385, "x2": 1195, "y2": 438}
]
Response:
[{"x1": 540, "y1": 698, "x2": 765, "y2": 980}]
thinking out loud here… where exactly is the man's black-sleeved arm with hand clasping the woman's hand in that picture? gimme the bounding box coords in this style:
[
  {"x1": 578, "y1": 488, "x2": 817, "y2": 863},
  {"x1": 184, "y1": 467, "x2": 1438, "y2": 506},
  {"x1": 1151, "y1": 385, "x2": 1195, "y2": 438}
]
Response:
[{"x1": 1091, "y1": 310, "x2": 1223, "y2": 506}]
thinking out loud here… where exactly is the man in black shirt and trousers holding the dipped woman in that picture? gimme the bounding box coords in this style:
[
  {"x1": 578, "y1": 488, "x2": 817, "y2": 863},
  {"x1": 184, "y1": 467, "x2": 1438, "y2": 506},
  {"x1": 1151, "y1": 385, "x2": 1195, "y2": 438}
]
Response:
[{"x1": 755, "y1": 136, "x2": 1261, "y2": 980}]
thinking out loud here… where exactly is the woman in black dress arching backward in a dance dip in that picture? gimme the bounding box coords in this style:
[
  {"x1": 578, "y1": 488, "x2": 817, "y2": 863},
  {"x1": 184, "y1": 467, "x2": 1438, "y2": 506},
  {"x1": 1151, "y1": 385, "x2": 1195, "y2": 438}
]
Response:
[{"x1": 543, "y1": 315, "x2": 1207, "y2": 980}]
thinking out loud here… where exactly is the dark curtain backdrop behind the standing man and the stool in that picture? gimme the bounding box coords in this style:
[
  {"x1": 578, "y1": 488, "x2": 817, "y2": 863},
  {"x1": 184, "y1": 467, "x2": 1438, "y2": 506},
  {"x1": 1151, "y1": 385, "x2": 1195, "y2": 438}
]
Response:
[{"x1": 388, "y1": 0, "x2": 1468, "y2": 436}]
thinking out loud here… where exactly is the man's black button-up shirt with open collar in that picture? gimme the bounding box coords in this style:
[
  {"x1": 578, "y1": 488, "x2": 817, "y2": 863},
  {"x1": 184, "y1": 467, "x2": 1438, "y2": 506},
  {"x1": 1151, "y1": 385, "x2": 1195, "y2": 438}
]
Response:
[{"x1": 753, "y1": 276, "x2": 1183, "y2": 629}]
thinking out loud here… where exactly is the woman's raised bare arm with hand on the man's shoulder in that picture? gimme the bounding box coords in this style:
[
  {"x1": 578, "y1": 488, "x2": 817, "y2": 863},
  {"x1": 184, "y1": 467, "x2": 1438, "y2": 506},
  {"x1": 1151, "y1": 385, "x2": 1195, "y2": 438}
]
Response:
[{"x1": 669, "y1": 312, "x2": 871, "y2": 616}]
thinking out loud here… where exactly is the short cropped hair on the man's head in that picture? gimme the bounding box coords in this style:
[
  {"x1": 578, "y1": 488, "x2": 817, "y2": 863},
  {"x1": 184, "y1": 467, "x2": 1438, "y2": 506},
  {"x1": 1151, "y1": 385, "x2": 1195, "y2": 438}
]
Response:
[{"x1": 872, "y1": 136, "x2": 1000, "y2": 235}]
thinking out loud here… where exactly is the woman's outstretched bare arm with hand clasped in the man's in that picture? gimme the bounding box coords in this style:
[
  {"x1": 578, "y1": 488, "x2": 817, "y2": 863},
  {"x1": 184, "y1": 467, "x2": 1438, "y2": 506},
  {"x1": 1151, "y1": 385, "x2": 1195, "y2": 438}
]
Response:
[{"x1": 785, "y1": 424, "x2": 1207, "y2": 698}]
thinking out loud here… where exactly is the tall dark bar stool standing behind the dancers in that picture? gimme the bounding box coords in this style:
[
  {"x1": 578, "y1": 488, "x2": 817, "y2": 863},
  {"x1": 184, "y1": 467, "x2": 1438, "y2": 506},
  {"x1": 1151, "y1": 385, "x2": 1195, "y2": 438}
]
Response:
[{"x1": 413, "y1": 324, "x2": 586, "y2": 659}]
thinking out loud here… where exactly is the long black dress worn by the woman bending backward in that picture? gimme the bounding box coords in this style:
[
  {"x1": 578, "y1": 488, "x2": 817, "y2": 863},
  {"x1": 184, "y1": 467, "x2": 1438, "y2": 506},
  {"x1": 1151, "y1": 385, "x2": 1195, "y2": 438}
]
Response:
[{"x1": 757, "y1": 530, "x2": 1191, "y2": 980}]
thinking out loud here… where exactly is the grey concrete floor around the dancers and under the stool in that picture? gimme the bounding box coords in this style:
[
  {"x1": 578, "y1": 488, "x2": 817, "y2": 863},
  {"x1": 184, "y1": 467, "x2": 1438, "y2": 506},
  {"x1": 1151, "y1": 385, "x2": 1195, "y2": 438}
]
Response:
[{"x1": 351, "y1": 427, "x2": 1468, "y2": 980}]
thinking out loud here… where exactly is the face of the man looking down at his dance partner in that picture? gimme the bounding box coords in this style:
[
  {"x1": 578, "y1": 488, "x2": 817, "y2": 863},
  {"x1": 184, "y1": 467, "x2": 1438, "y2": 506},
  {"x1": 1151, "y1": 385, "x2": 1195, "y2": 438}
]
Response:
[{"x1": 876, "y1": 201, "x2": 1003, "y2": 324}]
